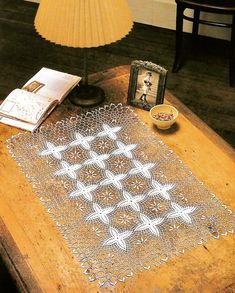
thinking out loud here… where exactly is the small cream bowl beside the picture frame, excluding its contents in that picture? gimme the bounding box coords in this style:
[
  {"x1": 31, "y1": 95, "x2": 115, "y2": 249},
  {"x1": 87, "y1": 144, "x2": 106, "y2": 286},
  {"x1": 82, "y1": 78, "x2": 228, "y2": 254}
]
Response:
[{"x1": 149, "y1": 104, "x2": 179, "y2": 129}]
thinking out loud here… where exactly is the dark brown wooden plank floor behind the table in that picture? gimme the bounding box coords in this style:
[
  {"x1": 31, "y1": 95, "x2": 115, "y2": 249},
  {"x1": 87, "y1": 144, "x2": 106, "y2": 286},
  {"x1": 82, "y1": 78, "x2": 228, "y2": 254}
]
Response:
[{"x1": 0, "y1": 0, "x2": 235, "y2": 147}]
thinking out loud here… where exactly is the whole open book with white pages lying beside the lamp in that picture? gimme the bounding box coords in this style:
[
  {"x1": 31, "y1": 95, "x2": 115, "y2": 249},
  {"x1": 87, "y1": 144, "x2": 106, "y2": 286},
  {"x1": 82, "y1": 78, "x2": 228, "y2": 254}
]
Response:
[{"x1": 0, "y1": 67, "x2": 81, "y2": 131}]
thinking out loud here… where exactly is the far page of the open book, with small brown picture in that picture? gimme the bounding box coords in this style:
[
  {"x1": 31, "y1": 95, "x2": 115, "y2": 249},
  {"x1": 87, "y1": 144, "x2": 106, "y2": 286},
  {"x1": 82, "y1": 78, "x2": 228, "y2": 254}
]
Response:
[{"x1": 22, "y1": 67, "x2": 81, "y2": 103}]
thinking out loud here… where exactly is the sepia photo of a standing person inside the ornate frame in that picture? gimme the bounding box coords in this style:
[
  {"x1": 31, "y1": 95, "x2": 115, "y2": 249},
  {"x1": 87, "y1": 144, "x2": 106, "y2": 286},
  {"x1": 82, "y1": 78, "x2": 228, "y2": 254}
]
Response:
[{"x1": 135, "y1": 68, "x2": 159, "y2": 108}]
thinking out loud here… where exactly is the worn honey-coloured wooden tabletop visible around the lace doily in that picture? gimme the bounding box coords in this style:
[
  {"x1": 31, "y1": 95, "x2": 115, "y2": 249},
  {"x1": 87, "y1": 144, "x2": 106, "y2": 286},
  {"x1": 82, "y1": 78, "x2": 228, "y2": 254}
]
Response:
[{"x1": 0, "y1": 66, "x2": 235, "y2": 293}]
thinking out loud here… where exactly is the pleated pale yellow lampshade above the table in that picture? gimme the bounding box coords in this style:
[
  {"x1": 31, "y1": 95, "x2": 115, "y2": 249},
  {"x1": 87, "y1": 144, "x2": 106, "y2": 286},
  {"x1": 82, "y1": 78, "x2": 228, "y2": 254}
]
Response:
[{"x1": 35, "y1": 0, "x2": 133, "y2": 48}]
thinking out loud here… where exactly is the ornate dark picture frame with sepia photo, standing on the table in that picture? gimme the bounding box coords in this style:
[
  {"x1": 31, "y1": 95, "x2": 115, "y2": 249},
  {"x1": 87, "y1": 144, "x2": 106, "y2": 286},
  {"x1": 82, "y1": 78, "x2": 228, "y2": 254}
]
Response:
[{"x1": 127, "y1": 60, "x2": 167, "y2": 110}]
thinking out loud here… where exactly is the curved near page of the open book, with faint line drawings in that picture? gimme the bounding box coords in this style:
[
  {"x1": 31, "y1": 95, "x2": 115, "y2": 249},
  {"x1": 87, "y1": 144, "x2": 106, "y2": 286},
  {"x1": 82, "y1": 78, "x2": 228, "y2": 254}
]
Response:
[{"x1": 0, "y1": 89, "x2": 55, "y2": 124}]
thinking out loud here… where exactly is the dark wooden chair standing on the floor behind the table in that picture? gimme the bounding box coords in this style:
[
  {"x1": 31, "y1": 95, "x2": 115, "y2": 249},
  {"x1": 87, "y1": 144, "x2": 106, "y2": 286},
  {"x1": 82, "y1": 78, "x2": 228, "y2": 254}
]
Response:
[{"x1": 172, "y1": 0, "x2": 235, "y2": 86}]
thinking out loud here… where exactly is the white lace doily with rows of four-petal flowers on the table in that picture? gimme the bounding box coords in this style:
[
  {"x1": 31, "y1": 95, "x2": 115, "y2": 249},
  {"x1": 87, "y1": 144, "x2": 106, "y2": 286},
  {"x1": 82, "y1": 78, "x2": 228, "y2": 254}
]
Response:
[{"x1": 8, "y1": 104, "x2": 235, "y2": 286}]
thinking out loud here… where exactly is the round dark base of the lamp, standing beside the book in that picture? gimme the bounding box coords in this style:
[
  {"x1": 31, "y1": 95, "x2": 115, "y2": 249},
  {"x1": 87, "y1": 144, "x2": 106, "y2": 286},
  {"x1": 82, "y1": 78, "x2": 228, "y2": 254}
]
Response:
[{"x1": 69, "y1": 84, "x2": 105, "y2": 107}]
